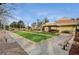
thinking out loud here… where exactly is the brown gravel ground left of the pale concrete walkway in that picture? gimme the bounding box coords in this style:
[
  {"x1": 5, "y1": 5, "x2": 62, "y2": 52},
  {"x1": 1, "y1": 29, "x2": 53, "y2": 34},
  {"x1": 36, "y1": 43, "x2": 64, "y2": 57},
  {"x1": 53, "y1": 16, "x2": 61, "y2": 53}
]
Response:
[{"x1": 0, "y1": 31, "x2": 27, "y2": 55}]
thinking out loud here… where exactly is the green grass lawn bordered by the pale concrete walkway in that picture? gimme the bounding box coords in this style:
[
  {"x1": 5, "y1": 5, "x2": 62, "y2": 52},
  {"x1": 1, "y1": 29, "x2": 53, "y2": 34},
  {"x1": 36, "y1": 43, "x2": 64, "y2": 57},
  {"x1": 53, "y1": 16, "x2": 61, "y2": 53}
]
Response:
[{"x1": 15, "y1": 31, "x2": 55, "y2": 42}]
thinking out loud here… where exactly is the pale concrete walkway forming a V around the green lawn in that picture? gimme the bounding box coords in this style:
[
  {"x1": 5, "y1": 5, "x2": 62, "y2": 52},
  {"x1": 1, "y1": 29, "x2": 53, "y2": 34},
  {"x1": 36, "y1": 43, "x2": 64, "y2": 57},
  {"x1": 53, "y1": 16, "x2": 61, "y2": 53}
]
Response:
[{"x1": 8, "y1": 32, "x2": 72, "y2": 55}]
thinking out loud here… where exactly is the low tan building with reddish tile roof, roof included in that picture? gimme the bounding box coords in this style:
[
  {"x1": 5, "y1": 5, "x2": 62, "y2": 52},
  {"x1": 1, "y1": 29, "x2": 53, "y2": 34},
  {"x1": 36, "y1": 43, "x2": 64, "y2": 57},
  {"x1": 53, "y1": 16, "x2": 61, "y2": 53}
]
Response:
[{"x1": 42, "y1": 18, "x2": 79, "y2": 33}]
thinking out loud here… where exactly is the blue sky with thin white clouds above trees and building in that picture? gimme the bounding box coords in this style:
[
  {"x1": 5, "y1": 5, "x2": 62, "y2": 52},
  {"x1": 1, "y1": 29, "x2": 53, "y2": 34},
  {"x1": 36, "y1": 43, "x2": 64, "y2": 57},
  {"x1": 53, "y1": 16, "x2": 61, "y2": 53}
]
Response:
[{"x1": 7, "y1": 3, "x2": 79, "y2": 25}]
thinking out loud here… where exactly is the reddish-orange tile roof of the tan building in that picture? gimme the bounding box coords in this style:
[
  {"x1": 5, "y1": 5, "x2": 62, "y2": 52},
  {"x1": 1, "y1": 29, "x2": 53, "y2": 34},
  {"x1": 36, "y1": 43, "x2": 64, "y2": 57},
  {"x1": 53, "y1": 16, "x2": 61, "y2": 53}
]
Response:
[{"x1": 44, "y1": 18, "x2": 79, "y2": 26}]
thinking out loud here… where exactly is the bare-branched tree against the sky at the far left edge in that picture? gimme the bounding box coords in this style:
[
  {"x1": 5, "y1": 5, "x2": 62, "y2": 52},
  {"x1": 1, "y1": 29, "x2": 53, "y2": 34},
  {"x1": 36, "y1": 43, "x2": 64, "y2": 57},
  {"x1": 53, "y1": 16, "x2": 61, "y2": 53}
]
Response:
[{"x1": 0, "y1": 3, "x2": 14, "y2": 30}]
